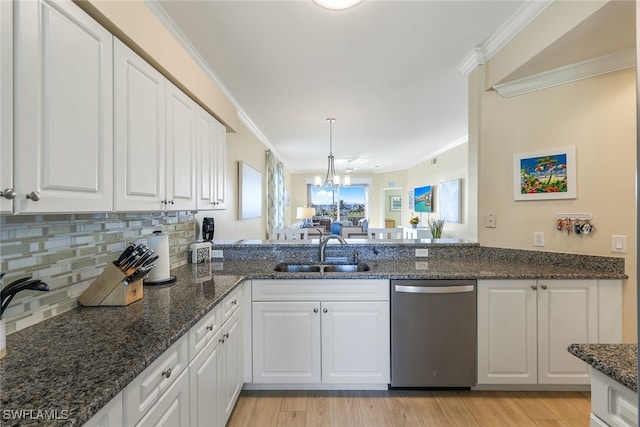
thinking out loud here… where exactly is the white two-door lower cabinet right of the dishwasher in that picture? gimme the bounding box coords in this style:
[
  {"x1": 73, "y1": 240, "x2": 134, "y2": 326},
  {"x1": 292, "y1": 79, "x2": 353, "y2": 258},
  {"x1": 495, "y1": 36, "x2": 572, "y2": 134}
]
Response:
[{"x1": 478, "y1": 280, "x2": 621, "y2": 385}]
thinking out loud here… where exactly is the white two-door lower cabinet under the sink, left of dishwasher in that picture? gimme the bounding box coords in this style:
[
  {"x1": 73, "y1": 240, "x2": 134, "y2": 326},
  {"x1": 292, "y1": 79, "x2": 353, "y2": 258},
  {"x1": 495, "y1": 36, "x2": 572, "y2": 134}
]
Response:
[{"x1": 252, "y1": 280, "x2": 390, "y2": 384}]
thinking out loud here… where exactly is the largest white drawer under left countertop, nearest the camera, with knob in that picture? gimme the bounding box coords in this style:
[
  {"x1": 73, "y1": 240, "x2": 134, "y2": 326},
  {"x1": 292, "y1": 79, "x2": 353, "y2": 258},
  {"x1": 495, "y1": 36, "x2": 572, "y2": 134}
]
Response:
[{"x1": 124, "y1": 335, "x2": 189, "y2": 425}]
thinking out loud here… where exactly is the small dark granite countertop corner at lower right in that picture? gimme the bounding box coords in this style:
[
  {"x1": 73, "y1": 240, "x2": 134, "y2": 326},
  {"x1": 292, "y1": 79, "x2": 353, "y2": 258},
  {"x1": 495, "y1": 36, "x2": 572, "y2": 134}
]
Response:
[{"x1": 567, "y1": 344, "x2": 638, "y2": 393}]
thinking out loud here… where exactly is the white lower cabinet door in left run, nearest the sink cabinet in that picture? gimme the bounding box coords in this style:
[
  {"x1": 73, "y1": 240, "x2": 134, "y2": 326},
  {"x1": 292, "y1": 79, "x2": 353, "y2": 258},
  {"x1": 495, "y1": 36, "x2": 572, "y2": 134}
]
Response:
[{"x1": 218, "y1": 311, "x2": 244, "y2": 426}]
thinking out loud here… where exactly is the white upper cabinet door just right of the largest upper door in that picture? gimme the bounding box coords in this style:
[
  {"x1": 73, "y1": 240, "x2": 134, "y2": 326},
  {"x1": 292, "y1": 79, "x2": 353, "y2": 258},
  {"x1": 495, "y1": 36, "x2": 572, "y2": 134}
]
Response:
[{"x1": 114, "y1": 39, "x2": 165, "y2": 211}]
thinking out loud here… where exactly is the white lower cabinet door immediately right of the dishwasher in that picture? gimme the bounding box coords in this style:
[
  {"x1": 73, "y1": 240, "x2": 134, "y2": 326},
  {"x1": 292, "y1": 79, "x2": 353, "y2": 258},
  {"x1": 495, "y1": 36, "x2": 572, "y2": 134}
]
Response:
[{"x1": 478, "y1": 280, "x2": 536, "y2": 384}]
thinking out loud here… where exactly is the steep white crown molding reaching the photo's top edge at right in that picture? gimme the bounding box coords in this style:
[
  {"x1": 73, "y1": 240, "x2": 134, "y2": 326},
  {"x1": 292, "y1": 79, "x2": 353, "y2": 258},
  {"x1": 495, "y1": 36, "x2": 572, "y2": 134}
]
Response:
[{"x1": 458, "y1": 0, "x2": 553, "y2": 75}]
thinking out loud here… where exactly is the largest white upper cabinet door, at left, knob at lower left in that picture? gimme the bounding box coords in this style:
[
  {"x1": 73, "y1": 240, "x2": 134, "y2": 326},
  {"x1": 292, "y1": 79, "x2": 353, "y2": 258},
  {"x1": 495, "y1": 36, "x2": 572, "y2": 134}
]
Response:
[{"x1": 13, "y1": 0, "x2": 113, "y2": 213}]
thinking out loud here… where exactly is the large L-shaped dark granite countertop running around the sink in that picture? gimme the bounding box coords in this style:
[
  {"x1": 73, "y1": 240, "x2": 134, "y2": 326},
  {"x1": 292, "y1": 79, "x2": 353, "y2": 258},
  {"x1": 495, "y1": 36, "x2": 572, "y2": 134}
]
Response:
[{"x1": 0, "y1": 251, "x2": 626, "y2": 426}]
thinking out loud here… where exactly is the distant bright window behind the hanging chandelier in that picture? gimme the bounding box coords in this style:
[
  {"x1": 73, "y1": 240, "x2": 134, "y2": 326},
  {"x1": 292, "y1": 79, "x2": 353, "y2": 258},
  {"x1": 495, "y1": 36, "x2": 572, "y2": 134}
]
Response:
[{"x1": 307, "y1": 184, "x2": 369, "y2": 225}]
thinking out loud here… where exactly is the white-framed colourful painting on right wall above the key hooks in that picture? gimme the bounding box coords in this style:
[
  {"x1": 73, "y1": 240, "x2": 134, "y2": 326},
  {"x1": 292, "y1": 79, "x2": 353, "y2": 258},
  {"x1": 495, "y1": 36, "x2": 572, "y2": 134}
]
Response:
[{"x1": 513, "y1": 147, "x2": 577, "y2": 201}]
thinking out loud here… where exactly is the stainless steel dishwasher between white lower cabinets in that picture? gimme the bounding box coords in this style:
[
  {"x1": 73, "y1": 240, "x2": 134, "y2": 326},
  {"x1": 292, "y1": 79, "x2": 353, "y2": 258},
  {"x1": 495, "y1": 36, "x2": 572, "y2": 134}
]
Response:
[{"x1": 391, "y1": 280, "x2": 477, "y2": 388}]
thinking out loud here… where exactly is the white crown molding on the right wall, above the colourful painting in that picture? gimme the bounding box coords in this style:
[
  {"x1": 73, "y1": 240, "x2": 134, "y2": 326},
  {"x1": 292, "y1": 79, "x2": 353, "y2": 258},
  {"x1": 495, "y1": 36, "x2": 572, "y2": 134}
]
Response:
[{"x1": 492, "y1": 48, "x2": 636, "y2": 98}]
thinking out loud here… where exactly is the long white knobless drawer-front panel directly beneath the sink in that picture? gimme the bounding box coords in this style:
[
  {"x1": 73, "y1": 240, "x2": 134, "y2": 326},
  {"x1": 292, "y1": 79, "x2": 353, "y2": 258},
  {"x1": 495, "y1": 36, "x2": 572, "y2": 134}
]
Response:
[{"x1": 252, "y1": 279, "x2": 390, "y2": 301}]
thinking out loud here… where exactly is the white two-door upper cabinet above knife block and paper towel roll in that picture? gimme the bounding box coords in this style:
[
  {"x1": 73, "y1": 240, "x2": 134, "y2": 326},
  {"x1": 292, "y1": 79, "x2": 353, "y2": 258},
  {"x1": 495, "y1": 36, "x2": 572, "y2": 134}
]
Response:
[{"x1": 114, "y1": 40, "x2": 198, "y2": 211}]
